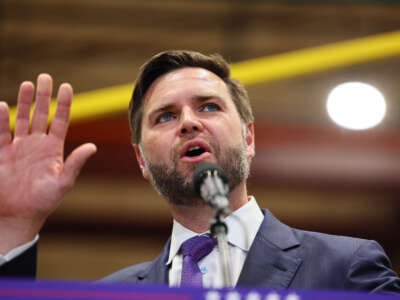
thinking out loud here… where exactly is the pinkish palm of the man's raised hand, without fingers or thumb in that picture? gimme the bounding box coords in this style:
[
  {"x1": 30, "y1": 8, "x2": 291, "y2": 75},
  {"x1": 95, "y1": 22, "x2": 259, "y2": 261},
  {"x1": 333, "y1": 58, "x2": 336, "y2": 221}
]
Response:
[{"x1": 0, "y1": 133, "x2": 66, "y2": 217}]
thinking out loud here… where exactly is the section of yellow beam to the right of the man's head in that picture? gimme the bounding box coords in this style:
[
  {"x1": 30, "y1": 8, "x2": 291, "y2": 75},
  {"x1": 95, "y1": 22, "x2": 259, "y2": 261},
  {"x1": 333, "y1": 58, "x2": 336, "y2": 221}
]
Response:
[{"x1": 232, "y1": 31, "x2": 400, "y2": 85}]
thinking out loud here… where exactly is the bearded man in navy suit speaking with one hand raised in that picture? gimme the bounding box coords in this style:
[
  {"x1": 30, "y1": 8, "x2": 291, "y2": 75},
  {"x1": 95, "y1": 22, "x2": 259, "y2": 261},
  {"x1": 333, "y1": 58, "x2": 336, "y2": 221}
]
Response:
[{"x1": 0, "y1": 51, "x2": 400, "y2": 292}]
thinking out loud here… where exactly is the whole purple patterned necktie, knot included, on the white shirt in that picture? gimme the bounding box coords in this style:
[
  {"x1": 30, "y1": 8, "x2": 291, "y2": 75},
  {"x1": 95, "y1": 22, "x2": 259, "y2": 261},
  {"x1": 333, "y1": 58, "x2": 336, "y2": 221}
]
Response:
[{"x1": 180, "y1": 235, "x2": 215, "y2": 287}]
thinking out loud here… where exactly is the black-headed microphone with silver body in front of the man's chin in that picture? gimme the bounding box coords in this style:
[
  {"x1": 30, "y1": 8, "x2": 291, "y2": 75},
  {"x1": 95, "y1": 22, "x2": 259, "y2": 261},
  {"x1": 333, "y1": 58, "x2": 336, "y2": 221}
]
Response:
[{"x1": 193, "y1": 162, "x2": 229, "y2": 213}]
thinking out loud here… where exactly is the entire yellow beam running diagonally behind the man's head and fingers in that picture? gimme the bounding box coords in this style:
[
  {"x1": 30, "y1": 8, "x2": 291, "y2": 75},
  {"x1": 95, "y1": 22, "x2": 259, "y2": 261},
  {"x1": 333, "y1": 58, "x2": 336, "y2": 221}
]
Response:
[{"x1": 10, "y1": 31, "x2": 400, "y2": 127}]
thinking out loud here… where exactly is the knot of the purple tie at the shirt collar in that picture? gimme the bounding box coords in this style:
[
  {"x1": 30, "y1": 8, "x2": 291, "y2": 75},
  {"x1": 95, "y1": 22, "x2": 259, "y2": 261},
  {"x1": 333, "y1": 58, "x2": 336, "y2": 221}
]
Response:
[{"x1": 181, "y1": 234, "x2": 215, "y2": 263}]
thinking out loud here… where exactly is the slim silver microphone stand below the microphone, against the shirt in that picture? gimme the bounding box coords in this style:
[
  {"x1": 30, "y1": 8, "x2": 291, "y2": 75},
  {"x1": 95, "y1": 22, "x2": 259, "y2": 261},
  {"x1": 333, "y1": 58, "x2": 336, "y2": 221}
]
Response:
[{"x1": 210, "y1": 209, "x2": 233, "y2": 287}]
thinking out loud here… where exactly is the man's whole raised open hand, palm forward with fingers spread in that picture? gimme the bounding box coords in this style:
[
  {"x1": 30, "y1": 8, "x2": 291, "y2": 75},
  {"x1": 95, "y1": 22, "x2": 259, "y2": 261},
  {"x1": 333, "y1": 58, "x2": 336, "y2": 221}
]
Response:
[{"x1": 0, "y1": 74, "x2": 96, "y2": 254}]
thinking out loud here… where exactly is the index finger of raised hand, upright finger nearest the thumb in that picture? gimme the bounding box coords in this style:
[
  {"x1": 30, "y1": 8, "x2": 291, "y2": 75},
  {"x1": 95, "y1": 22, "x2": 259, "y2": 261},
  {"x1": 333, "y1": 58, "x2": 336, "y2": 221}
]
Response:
[{"x1": 49, "y1": 83, "x2": 73, "y2": 140}]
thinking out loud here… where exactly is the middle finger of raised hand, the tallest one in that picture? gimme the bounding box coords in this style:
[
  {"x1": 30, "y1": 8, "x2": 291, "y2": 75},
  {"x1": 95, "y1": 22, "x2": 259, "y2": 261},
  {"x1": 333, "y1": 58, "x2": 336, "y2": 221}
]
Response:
[{"x1": 31, "y1": 74, "x2": 53, "y2": 132}]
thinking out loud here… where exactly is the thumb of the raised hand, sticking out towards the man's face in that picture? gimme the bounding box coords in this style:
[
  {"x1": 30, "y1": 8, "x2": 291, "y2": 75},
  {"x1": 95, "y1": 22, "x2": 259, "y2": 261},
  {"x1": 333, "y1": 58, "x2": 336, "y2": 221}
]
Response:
[{"x1": 61, "y1": 143, "x2": 97, "y2": 189}]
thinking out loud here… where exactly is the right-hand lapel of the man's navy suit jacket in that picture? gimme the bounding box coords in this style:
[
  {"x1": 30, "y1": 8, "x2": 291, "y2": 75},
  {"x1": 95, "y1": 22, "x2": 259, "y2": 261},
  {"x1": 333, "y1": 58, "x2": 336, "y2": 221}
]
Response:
[{"x1": 237, "y1": 210, "x2": 302, "y2": 288}]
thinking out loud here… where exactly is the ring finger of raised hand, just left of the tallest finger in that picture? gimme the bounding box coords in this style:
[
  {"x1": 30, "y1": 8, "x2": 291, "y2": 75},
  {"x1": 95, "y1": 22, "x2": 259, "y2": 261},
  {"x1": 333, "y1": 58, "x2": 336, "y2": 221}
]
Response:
[{"x1": 14, "y1": 81, "x2": 35, "y2": 137}]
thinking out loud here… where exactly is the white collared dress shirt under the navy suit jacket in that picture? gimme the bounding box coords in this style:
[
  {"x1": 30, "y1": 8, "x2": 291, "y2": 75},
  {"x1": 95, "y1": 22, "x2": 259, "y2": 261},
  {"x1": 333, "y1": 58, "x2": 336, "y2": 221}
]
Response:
[{"x1": 167, "y1": 196, "x2": 264, "y2": 288}]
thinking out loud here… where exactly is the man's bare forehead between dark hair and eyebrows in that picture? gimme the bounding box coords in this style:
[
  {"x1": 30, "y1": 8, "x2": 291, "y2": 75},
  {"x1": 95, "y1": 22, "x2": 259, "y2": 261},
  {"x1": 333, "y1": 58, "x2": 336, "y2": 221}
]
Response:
[{"x1": 144, "y1": 67, "x2": 229, "y2": 106}]
